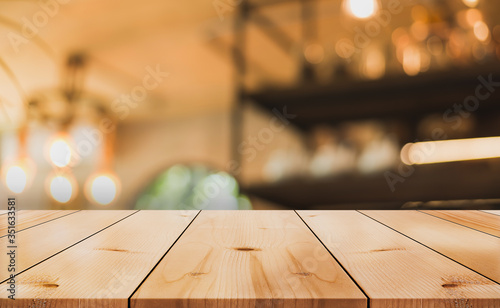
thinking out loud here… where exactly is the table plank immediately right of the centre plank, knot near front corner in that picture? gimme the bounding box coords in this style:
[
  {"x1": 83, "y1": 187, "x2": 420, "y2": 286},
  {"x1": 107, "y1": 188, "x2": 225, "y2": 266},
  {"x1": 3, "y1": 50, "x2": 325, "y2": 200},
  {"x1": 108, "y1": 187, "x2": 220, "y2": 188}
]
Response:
[{"x1": 298, "y1": 211, "x2": 500, "y2": 308}]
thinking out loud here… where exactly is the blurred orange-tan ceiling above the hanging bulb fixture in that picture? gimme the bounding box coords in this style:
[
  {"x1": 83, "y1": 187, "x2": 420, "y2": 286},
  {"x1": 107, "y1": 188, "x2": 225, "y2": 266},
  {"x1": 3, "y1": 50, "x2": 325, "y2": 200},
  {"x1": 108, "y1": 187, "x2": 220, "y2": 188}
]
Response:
[{"x1": 0, "y1": 0, "x2": 236, "y2": 125}]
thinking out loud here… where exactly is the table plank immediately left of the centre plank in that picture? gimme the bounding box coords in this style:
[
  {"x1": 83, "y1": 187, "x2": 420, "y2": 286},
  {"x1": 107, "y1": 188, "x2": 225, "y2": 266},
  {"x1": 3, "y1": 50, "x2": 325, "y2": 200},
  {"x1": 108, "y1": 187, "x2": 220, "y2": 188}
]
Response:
[{"x1": 0, "y1": 211, "x2": 198, "y2": 308}]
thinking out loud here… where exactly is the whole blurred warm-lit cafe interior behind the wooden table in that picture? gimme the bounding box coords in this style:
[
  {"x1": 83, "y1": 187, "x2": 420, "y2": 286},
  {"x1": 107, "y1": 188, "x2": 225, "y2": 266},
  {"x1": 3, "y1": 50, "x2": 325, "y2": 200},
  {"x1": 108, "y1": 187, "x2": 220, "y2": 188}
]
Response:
[{"x1": 0, "y1": 0, "x2": 500, "y2": 210}]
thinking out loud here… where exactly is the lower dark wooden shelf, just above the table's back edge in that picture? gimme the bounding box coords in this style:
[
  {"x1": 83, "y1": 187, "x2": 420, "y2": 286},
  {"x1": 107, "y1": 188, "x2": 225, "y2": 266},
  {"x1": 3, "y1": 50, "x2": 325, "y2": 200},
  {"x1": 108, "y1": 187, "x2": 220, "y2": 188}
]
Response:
[{"x1": 244, "y1": 159, "x2": 500, "y2": 209}]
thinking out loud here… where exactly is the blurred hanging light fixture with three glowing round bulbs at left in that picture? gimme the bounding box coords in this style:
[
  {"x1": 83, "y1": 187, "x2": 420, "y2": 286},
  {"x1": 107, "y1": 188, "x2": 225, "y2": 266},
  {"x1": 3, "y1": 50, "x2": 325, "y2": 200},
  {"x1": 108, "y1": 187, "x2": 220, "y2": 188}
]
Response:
[{"x1": 0, "y1": 42, "x2": 124, "y2": 205}]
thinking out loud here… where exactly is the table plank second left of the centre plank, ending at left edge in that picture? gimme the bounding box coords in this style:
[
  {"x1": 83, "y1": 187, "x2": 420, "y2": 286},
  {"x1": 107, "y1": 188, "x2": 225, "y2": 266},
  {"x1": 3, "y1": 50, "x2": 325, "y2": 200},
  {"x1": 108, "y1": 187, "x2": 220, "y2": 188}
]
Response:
[{"x1": 0, "y1": 211, "x2": 136, "y2": 282}]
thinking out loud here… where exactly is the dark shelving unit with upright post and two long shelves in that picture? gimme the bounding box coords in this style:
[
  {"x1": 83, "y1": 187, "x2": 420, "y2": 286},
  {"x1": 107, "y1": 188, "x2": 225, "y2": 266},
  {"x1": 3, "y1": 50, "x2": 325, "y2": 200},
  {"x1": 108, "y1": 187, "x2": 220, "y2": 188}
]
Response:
[{"x1": 232, "y1": 1, "x2": 500, "y2": 209}]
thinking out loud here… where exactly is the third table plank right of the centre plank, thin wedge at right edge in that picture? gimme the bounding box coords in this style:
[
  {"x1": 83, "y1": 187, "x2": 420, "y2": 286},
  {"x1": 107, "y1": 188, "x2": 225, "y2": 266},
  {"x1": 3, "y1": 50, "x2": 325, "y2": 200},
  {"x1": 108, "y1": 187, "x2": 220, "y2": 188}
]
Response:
[{"x1": 421, "y1": 210, "x2": 500, "y2": 237}]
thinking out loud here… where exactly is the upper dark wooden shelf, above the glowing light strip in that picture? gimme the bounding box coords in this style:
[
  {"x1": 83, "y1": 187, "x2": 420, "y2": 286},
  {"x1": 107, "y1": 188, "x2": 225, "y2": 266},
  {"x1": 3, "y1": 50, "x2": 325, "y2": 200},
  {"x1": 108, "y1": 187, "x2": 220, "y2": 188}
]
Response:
[{"x1": 246, "y1": 61, "x2": 500, "y2": 129}]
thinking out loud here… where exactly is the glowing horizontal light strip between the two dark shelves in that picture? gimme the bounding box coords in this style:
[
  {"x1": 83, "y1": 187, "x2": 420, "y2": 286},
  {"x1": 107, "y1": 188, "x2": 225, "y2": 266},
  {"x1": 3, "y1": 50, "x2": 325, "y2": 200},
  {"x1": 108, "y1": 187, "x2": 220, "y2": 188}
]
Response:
[{"x1": 400, "y1": 137, "x2": 500, "y2": 165}]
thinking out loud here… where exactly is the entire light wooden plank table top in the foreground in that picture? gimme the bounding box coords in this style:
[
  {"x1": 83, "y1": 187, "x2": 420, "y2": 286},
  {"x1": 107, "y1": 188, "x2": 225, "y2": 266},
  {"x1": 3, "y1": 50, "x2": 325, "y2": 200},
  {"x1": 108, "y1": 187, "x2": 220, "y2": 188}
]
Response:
[{"x1": 0, "y1": 211, "x2": 500, "y2": 308}]
